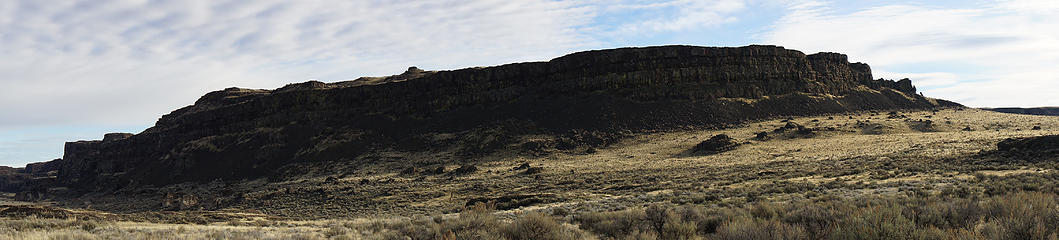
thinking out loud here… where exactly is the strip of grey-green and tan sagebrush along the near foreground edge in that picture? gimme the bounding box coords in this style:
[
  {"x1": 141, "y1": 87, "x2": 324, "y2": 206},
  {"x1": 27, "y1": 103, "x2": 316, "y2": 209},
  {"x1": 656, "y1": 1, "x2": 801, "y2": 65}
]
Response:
[{"x1": 8, "y1": 192, "x2": 1059, "y2": 237}]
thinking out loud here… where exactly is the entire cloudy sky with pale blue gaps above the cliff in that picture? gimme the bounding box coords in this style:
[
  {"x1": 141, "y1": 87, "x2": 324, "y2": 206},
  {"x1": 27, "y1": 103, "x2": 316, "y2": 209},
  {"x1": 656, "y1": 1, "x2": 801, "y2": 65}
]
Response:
[{"x1": 0, "y1": 0, "x2": 1059, "y2": 166}]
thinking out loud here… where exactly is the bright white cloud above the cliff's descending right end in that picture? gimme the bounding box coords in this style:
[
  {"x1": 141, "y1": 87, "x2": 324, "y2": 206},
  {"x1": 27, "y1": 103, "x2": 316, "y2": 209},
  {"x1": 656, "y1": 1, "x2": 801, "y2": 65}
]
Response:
[{"x1": 762, "y1": 0, "x2": 1059, "y2": 107}]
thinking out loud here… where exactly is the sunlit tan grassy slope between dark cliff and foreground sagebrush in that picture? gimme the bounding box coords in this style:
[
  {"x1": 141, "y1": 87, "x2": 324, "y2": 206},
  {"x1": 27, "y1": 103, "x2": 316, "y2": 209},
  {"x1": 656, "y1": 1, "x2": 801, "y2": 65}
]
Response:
[{"x1": 55, "y1": 110, "x2": 1059, "y2": 219}]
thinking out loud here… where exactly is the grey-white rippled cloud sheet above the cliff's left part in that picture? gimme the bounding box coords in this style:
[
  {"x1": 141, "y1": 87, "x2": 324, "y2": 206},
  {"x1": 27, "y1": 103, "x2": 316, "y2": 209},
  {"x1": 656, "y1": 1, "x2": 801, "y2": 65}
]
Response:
[{"x1": 0, "y1": 0, "x2": 592, "y2": 127}]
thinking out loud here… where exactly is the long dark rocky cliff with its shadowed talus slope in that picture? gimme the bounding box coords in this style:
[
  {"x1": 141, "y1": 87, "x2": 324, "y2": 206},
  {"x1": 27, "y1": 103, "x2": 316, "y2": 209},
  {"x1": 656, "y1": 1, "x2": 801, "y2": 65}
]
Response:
[{"x1": 47, "y1": 45, "x2": 955, "y2": 190}]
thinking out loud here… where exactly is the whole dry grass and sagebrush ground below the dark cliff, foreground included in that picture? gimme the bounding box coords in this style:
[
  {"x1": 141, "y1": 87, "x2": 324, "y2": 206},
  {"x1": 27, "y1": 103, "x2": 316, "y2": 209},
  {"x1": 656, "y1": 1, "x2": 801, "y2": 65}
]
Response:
[{"x1": 0, "y1": 110, "x2": 1059, "y2": 239}]
